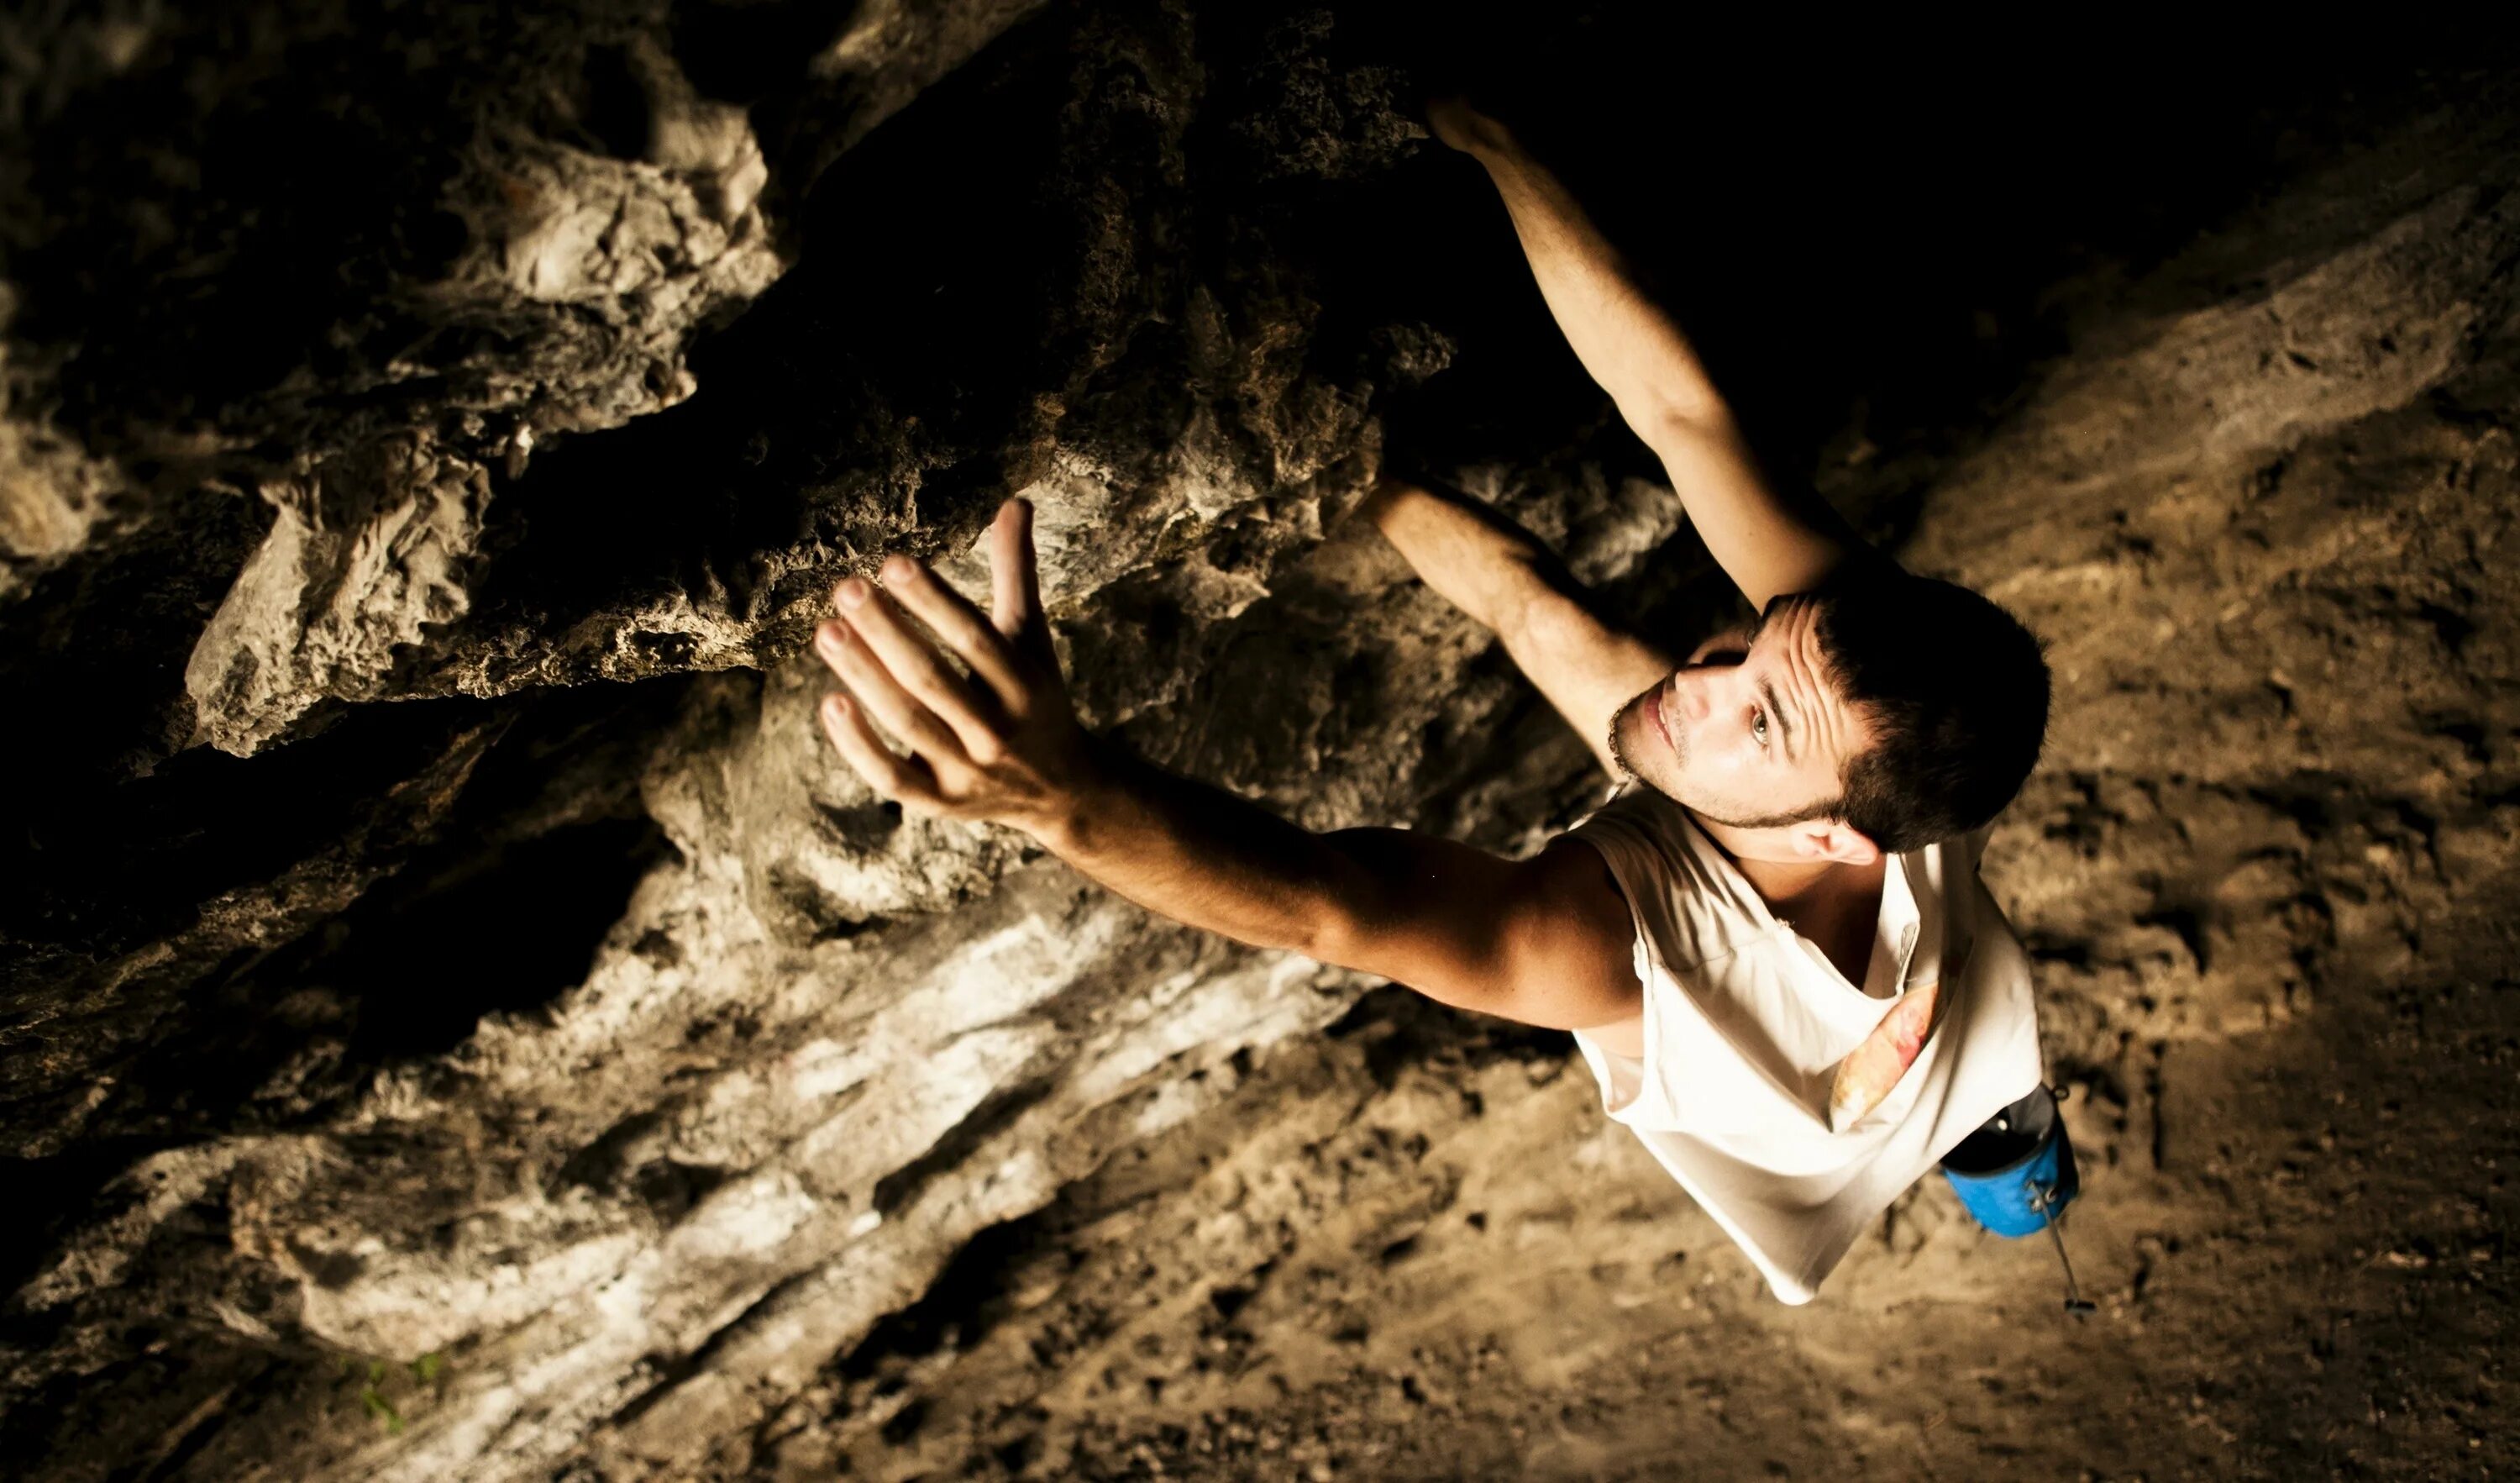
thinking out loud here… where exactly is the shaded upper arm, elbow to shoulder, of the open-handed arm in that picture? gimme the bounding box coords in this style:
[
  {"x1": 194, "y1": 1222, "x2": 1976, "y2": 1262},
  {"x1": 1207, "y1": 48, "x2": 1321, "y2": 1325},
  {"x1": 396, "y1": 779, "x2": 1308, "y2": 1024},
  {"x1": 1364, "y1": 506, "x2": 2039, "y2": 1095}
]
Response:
[{"x1": 1318, "y1": 830, "x2": 1641, "y2": 1029}]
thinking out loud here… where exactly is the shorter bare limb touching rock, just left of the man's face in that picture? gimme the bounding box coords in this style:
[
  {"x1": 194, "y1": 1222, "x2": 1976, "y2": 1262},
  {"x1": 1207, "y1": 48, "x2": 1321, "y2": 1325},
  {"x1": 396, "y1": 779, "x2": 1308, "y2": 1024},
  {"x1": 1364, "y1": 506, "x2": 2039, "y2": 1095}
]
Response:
[{"x1": 1358, "y1": 476, "x2": 1676, "y2": 777}]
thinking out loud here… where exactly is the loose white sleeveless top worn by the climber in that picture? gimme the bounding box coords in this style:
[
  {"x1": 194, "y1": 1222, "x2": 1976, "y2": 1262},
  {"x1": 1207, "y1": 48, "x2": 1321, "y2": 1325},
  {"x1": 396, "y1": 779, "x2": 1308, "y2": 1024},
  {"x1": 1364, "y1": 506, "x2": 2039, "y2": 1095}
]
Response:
[{"x1": 1567, "y1": 782, "x2": 2044, "y2": 1304}]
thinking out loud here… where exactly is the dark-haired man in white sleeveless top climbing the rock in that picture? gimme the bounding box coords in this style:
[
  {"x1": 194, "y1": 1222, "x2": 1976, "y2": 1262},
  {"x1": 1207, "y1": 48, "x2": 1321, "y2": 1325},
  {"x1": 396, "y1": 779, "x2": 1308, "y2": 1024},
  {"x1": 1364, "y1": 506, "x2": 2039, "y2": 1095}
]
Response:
[{"x1": 816, "y1": 101, "x2": 2049, "y2": 1304}]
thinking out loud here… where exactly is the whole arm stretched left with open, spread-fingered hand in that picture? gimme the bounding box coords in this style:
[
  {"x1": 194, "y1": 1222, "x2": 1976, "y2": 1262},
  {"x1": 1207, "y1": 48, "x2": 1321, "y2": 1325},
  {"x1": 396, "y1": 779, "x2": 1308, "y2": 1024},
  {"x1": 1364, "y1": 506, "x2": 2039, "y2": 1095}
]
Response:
[{"x1": 814, "y1": 499, "x2": 1638, "y2": 1029}]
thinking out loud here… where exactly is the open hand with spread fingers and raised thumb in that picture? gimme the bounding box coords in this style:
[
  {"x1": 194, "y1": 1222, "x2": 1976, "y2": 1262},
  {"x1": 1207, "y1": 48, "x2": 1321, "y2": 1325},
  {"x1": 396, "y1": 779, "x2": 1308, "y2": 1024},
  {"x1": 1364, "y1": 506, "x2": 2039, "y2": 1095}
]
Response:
[{"x1": 814, "y1": 499, "x2": 1094, "y2": 833}]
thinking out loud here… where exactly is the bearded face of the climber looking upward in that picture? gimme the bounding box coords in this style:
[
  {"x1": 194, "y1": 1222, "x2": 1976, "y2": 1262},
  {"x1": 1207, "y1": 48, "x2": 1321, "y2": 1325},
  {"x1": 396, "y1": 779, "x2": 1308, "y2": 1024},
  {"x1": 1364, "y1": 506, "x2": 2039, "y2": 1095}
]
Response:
[{"x1": 1610, "y1": 602, "x2": 1870, "y2": 830}]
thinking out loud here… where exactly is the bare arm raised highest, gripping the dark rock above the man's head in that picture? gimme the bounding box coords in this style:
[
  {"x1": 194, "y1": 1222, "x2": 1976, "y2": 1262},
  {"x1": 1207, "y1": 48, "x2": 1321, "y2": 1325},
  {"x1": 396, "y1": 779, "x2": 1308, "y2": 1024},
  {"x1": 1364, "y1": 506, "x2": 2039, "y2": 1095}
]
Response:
[{"x1": 1429, "y1": 98, "x2": 1885, "y2": 607}]
